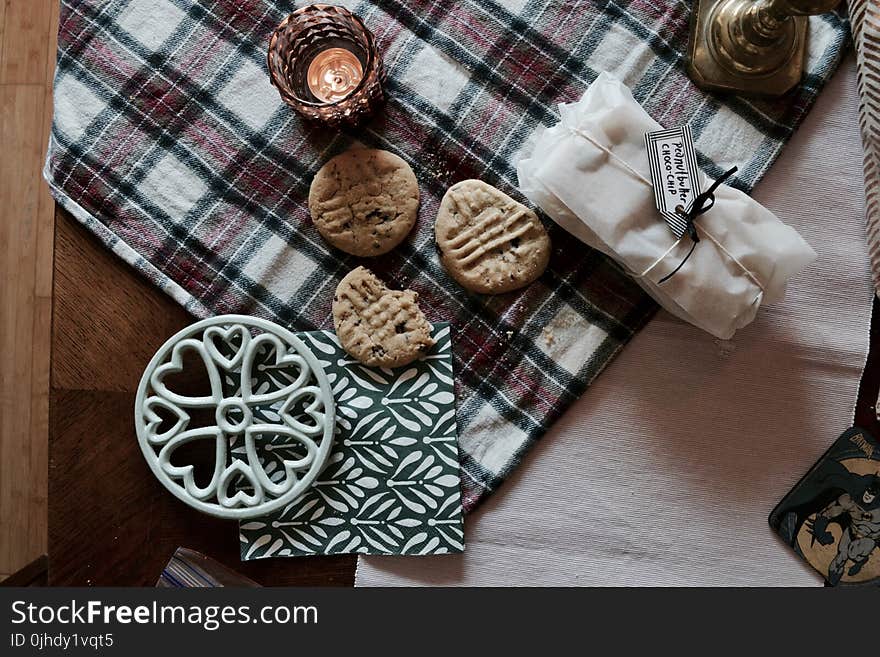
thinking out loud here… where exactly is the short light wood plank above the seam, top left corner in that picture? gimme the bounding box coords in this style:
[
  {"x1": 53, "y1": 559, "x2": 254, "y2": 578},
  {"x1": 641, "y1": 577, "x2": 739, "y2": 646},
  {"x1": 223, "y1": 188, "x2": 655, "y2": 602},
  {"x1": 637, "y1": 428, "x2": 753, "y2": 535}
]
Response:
[{"x1": 0, "y1": 0, "x2": 57, "y2": 84}]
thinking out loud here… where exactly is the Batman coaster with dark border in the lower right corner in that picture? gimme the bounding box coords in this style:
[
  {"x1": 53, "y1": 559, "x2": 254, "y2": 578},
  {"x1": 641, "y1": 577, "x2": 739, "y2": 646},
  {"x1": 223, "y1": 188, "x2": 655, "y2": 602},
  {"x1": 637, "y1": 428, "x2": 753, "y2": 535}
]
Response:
[{"x1": 769, "y1": 428, "x2": 880, "y2": 586}]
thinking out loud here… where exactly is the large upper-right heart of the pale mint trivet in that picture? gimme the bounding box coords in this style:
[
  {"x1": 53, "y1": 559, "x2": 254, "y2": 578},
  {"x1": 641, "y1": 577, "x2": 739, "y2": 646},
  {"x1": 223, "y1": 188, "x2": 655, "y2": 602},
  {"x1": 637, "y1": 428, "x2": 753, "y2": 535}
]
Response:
[{"x1": 241, "y1": 333, "x2": 312, "y2": 404}]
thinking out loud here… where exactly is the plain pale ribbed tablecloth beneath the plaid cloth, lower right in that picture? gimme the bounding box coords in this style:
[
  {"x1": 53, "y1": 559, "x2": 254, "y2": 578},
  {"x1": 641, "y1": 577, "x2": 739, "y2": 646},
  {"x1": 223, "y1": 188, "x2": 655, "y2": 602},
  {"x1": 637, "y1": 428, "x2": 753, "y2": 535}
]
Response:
[{"x1": 357, "y1": 60, "x2": 872, "y2": 586}]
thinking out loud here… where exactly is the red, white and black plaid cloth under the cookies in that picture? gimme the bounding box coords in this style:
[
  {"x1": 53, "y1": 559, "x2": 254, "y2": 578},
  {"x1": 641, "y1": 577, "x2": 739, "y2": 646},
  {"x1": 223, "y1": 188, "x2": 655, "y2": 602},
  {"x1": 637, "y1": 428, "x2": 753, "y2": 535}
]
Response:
[{"x1": 45, "y1": 0, "x2": 847, "y2": 510}]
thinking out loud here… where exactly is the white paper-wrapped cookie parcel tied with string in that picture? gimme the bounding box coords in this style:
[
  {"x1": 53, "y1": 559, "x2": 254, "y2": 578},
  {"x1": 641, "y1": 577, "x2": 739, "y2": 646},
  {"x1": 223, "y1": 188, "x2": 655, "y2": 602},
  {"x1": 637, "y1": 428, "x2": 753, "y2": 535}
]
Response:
[{"x1": 517, "y1": 73, "x2": 816, "y2": 339}]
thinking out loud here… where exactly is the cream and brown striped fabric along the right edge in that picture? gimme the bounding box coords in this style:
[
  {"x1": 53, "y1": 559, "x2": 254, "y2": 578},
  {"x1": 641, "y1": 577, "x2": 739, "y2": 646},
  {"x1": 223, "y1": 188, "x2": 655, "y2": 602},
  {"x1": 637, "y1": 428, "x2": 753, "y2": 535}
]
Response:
[{"x1": 849, "y1": 0, "x2": 880, "y2": 292}]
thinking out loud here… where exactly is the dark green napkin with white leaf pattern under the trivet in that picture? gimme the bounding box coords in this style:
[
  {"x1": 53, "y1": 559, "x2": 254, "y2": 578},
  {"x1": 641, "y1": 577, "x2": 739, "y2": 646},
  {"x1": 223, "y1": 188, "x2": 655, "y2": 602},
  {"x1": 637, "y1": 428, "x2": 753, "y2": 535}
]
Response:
[{"x1": 240, "y1": 324, "x2": 464, "y2": 561}]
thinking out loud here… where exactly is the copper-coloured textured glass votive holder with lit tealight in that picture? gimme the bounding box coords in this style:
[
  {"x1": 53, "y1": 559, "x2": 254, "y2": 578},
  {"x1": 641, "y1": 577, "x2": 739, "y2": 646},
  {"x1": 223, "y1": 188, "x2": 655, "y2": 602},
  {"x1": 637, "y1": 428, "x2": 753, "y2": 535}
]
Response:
[{"x1": 267, "y1": 4, "x2": 385, "y2": 128}]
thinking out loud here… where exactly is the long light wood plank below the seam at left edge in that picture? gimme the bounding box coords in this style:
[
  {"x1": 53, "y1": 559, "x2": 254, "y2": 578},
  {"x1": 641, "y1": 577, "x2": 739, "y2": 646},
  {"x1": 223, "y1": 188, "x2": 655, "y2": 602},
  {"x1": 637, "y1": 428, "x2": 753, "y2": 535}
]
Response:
[{"x1": 0, "y1": 83, "x2": 45, "y2": 572}]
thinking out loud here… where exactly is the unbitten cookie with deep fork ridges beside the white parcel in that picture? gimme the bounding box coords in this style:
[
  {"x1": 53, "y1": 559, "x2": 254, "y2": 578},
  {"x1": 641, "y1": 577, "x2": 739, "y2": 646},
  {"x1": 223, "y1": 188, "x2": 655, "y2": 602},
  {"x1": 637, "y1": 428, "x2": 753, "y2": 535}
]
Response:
[{"x1": 434, "y1": 180, "x2": 550, "y2": 294}]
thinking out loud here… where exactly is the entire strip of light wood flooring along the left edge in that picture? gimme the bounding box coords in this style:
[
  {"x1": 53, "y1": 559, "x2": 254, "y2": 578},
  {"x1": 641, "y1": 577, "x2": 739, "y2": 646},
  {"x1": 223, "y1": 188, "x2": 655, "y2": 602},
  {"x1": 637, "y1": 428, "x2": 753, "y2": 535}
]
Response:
[{"x1": 0, "y1": 0, "x2": 59, "y2": 573}]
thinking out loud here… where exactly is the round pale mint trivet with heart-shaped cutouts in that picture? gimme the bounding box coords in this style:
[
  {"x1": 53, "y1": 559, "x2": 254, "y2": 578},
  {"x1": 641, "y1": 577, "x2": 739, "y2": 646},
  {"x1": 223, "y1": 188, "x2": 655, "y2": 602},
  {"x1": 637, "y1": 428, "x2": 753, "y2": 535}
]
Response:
[{"x1": 135, "y1": 315, "x2": 336, "y2": 520}]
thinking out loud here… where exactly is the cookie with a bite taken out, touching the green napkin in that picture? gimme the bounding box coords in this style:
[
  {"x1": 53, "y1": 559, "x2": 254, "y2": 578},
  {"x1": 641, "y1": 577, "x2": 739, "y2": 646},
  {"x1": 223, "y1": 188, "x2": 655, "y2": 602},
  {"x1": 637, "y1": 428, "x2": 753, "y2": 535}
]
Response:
[{"x1": 333, "y1": 267, "x2": 434, "y2": 367}]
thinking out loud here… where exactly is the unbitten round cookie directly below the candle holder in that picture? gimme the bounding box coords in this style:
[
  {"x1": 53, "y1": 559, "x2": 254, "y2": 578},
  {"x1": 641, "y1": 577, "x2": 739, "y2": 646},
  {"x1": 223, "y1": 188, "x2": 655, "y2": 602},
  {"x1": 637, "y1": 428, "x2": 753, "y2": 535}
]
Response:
[{"x1": 309, "y1": 149, "x2": 419, "y2": 257}]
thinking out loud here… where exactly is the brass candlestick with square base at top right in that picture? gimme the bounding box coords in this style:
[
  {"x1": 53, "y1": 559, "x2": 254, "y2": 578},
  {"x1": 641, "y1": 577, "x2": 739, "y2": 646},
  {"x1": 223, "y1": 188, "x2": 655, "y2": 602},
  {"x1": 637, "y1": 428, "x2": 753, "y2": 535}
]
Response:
[{"x1": 688, "y1": 0, "x2": 840, "y2": 96}]
